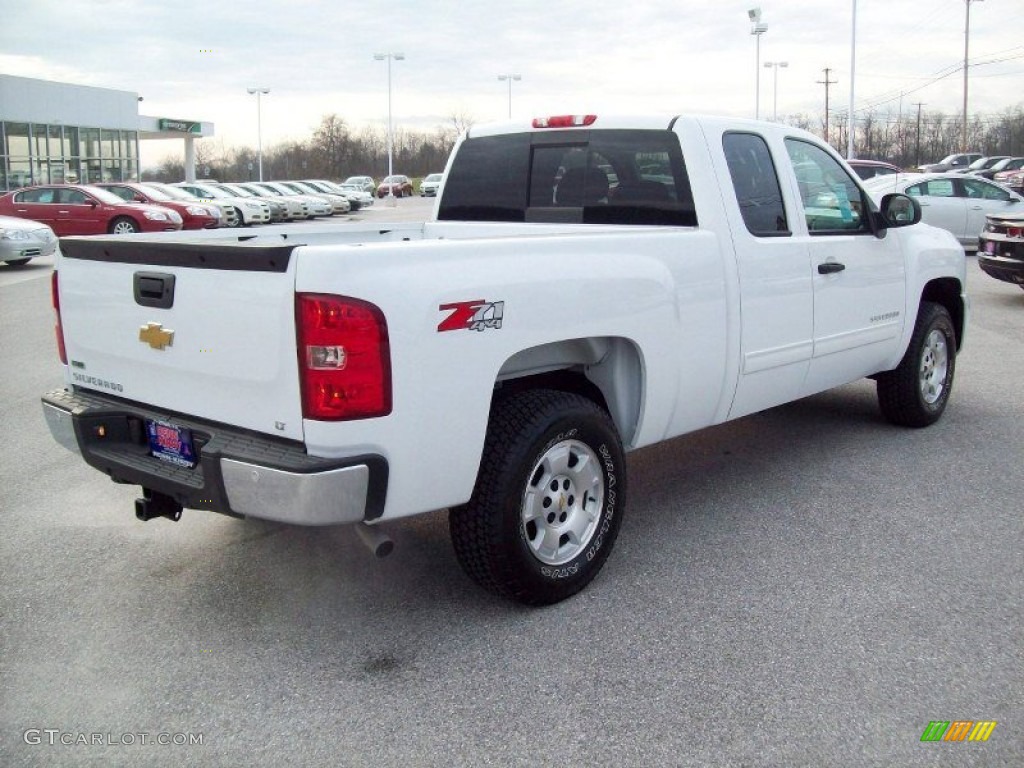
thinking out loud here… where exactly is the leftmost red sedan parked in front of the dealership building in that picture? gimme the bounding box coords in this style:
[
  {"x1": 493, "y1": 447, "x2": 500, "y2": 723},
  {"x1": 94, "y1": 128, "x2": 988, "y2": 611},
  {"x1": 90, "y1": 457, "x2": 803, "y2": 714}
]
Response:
[{"x1": 0, "y1": 184, "x2": 181, "y2": 237}]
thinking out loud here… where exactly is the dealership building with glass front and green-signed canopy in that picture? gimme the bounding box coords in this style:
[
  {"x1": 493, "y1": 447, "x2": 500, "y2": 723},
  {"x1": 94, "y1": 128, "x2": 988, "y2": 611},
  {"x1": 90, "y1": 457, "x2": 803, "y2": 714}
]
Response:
[{"x1": 0, "y1": 75, "x2": 213, "y2": 191}]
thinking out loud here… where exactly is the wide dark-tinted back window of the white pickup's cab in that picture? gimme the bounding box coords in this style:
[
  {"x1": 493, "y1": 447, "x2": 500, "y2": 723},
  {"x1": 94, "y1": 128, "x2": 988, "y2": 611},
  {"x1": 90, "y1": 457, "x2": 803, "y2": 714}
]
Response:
[{"x1": 437, "y1": 130, "x2": 697, "y2": 226}]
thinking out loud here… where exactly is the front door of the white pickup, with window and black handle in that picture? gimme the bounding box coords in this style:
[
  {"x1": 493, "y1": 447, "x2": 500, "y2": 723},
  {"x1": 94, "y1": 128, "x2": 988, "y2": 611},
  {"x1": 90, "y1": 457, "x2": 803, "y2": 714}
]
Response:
[{"x1": 785, "y1": 138, "x2": 915, "y2": 394}]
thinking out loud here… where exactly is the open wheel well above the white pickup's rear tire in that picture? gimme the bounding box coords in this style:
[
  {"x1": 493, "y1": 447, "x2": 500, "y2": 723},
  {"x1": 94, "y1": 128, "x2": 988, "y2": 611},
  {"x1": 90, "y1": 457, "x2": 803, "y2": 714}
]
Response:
[{"x1": 495, "y1": 337, "x2": 643, "y2": 446}]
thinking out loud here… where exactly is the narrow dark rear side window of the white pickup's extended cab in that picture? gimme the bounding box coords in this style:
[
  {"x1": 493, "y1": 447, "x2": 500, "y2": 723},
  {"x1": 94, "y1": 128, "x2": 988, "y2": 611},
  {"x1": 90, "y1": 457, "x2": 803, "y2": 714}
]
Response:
[{"x1": 722, "y1": 133, "x2": 791, "y2": 238}]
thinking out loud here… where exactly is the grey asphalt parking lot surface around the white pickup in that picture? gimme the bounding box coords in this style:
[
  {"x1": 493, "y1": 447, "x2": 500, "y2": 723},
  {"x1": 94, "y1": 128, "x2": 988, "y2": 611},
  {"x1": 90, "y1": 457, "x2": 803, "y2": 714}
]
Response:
[{"x1": 0, "y1": 207, "x2": 1024, "y2": 768}]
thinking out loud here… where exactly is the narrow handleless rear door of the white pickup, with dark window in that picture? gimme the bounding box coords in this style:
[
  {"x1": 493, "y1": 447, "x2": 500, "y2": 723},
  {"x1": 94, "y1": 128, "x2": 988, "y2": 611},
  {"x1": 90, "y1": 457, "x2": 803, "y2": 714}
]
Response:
[{"x1": 722, "y1": 132, "x2": 814, "y2": 418}]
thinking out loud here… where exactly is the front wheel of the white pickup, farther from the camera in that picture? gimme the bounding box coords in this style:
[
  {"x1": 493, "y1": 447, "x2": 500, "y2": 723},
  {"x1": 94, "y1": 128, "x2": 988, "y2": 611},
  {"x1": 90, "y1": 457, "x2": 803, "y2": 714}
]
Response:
[{"x1": 877, "y1": 301, "x2": 956, "y2": 427}]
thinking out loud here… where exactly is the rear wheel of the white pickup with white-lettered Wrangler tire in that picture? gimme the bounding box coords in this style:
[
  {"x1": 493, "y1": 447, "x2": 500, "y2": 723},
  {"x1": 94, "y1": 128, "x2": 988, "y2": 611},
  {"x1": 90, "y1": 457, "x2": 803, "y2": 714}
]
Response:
[{"x1": 449, "y1": 389, "x2": 626, "y2": 605}]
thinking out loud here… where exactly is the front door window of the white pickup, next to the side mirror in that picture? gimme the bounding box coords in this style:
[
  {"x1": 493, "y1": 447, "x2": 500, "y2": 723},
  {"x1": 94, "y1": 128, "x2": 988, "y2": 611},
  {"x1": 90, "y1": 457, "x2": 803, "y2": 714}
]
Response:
[{"x1": 785, "y1": 138, "x2": 871, "y2": 234}]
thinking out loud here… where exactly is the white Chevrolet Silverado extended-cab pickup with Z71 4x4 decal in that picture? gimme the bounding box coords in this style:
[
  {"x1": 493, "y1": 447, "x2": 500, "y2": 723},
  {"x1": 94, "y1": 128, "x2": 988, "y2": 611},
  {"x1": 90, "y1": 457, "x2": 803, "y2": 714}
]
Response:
[{"x1": 43, "y1": 115, "x2": 968, "y2": 604}]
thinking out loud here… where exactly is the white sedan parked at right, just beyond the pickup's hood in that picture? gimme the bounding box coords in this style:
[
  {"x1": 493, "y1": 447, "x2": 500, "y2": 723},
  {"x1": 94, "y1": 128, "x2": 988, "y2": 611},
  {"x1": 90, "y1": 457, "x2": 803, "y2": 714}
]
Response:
[{"x1": 864, "y1": 173, "x2": 1024, "y2": 251}]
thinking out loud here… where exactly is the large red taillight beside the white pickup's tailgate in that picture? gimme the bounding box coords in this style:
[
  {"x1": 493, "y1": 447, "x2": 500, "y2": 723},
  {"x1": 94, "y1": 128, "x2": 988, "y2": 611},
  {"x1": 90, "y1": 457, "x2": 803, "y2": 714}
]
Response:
[{"x1": 295, "y1": 294, "x2": 391, "y2": 421}]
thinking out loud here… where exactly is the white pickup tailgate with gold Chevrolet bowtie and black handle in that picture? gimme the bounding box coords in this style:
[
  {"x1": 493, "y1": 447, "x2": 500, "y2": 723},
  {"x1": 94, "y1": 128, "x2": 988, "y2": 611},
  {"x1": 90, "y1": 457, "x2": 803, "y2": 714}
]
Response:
[{"x1": 57, "y1": 236, "x2": 302, "y2": 440}]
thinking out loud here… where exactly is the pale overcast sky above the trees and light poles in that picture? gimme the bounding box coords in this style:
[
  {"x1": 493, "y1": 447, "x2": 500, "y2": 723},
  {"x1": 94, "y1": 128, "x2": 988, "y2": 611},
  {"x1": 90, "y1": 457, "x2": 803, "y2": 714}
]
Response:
[{"x1": 0, "y1": 0, "x2": 1024, "y2": 164}]
